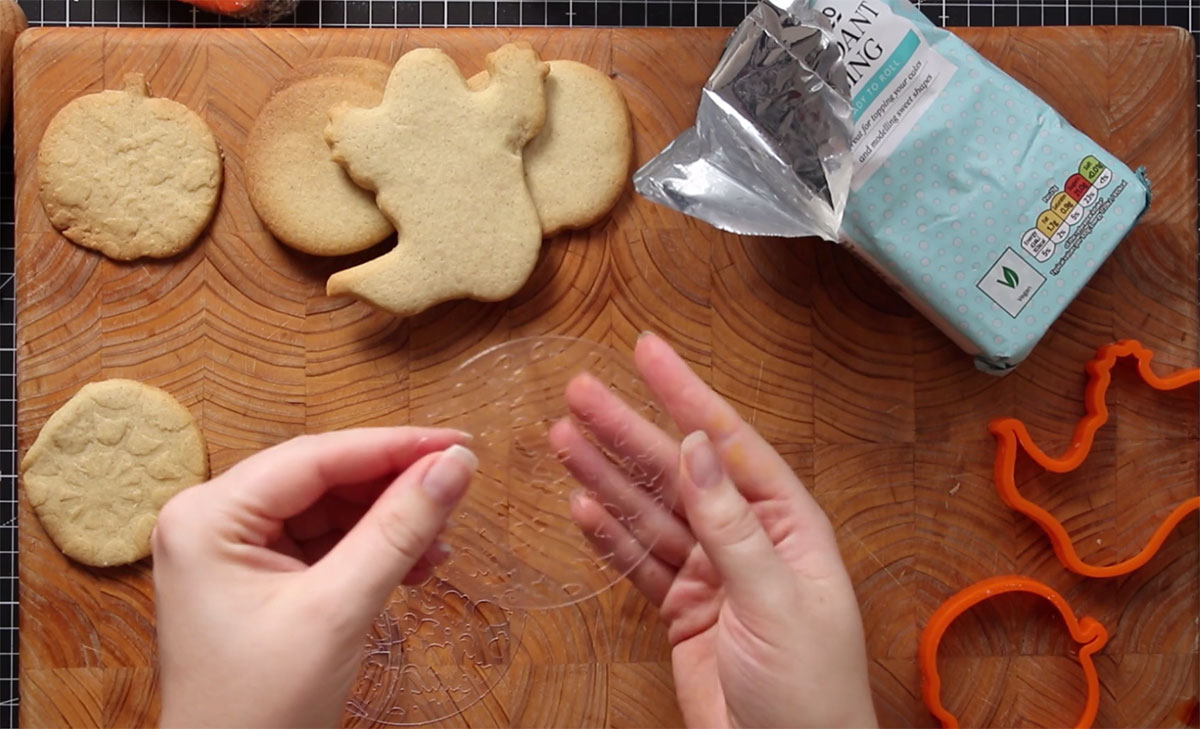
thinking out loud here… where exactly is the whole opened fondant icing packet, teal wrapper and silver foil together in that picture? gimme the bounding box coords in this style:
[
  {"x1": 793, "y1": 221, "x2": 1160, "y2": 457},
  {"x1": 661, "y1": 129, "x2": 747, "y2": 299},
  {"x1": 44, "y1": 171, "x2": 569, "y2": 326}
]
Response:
[{"x1": 634, "y1": 0, "x2": 1150, "y2": 374}]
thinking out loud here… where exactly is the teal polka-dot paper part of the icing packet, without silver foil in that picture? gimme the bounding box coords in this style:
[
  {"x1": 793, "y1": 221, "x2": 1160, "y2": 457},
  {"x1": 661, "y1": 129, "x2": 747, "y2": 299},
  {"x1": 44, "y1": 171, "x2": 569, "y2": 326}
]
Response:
[{"x1": 812, "y1": 0, "x2": 1150, "y2": 373}]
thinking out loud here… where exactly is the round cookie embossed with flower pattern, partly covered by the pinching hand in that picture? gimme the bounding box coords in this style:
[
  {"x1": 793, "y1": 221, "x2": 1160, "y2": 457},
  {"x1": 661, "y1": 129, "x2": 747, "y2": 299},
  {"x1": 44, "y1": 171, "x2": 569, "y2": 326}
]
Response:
[{"x1": 20, "y1": 380, "x2": 209, "y2": 567}]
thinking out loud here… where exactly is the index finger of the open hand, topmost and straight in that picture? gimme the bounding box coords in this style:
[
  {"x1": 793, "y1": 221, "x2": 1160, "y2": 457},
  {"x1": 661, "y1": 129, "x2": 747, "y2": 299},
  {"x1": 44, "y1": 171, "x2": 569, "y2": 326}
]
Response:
[{"x1": 634, "y1": 333, "x2": 822, "y2": 516}]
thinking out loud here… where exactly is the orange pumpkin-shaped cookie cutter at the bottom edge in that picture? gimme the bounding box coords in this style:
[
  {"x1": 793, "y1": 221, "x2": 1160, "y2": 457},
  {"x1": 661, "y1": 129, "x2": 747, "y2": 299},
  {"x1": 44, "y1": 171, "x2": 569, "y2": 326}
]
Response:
[{"x1": 917, "y1": 574, "x2": 1109, "y2": 729}]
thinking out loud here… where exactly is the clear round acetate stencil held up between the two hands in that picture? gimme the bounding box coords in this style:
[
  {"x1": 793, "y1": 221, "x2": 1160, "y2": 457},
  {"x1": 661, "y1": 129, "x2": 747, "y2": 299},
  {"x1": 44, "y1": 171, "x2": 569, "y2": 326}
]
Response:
[{"x1": 414, "y1": 337, "x2": 672, "y2": 609}]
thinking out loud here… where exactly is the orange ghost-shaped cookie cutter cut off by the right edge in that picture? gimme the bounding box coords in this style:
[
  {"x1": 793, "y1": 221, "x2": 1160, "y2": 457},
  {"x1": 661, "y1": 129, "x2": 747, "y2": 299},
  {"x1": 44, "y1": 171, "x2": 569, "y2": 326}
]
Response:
[{"x1": 988, "y1": 339, "x2": 1200, "y2": 577}]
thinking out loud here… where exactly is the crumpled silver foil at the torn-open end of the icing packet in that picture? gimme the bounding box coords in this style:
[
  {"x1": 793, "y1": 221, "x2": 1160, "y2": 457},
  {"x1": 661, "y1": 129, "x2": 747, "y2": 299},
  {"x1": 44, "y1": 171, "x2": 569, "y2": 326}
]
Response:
[{"x1": 634, "y1": 0, "x2": 853, "y2": 241}]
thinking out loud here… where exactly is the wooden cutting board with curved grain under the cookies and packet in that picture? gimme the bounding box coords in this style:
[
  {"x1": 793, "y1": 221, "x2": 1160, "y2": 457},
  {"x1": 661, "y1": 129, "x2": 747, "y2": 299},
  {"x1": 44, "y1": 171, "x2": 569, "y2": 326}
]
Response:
[{"x1": 16, "y1": 28, "x2": 1200, "y2": 727}]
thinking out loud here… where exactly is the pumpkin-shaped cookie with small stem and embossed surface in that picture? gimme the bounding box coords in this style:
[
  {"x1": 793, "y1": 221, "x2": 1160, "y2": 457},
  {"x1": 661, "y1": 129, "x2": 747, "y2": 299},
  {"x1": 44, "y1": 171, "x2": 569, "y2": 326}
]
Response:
[{"x1": 37, "y1": 73, "x2": 221, "y2": 260}]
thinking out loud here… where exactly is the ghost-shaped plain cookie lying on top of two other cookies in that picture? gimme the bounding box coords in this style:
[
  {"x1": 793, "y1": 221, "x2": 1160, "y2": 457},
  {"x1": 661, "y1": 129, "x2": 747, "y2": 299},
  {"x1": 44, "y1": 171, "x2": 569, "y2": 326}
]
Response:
[{"x1": 325, "y1": 44, "x2": 548, "y2": 315}]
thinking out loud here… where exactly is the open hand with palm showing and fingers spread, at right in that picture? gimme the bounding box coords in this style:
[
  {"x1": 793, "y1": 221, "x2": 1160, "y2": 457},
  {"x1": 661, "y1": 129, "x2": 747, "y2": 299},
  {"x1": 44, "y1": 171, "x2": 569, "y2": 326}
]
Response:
[{"x1": 550, "y1": 335, "x2": 876, "y2": 728}]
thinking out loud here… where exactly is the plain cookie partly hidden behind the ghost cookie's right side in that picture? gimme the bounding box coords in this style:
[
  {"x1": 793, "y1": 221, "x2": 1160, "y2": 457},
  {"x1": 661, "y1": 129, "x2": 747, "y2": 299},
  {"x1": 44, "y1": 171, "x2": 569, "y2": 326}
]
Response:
[{"x1": 469, "y1": 60, "x2": 634, "y2": 237}]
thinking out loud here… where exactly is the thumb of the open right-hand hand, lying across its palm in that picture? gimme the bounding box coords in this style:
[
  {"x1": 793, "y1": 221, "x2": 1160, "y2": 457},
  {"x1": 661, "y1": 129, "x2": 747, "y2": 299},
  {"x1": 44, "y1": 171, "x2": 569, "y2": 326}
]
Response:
[{"x1": 679, "y1": 430, "x2": 791, "y2": 607}]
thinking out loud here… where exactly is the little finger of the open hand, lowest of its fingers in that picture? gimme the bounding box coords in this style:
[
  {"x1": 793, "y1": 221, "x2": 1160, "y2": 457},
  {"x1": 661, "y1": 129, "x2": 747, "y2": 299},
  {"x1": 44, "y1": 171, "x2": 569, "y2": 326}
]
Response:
[{"x1": 570, "y1": 492, "x2": 677, "y2": 606}]
